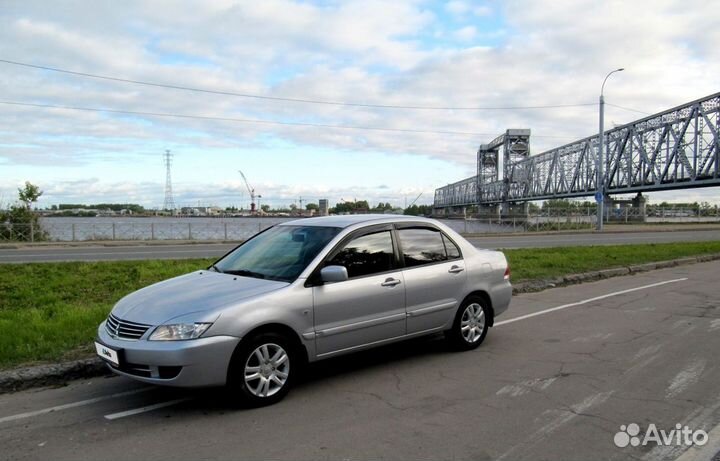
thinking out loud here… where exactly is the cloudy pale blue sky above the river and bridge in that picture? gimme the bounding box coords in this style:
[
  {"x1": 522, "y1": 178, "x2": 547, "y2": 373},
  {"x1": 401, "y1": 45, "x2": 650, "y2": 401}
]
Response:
[{"x1": 0, "y1": 0, "x2": 720, "y2": 208}]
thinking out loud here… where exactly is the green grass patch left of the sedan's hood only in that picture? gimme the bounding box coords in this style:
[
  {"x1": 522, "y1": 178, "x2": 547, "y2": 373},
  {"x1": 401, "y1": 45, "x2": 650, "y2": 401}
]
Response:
[{"x1": 0, "y1": 259, "x2": 211, "y2": 368}]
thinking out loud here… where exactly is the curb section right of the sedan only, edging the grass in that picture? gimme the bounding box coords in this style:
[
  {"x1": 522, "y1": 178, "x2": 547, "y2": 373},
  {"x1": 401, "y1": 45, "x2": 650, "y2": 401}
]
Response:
[{"x1": 513, "y1": 253, "x2": 720, "y2": 294}]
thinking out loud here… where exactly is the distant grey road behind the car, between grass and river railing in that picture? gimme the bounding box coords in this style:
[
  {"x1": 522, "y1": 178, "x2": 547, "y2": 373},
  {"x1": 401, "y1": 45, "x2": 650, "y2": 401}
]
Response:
[{"x1": 0, "y1": 229, "x2": 720, "y2": 263}]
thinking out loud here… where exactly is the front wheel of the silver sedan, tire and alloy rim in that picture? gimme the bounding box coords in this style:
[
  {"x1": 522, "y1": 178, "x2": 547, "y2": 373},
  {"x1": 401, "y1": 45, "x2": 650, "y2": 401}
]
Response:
[{"x1": 226, "y1": 333, "x2": 300, "y2": 407}]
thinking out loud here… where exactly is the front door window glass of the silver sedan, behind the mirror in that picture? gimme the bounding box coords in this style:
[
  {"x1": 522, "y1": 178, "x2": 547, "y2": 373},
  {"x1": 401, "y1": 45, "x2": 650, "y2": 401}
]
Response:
[{"x1": 325, "y1": 231, "x2": 395, "y2": 278}]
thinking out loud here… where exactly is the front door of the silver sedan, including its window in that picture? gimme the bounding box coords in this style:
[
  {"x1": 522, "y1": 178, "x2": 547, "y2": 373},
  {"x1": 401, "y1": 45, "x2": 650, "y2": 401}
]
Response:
[{"x1": 312, "y1": 226, "x2": 405, "y2": 357}]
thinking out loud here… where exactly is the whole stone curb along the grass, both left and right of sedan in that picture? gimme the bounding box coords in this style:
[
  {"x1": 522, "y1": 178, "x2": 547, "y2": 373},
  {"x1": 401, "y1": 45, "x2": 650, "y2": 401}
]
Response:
[{"x1": 0, "y1": 253, "x2": 720, "y2": 394}]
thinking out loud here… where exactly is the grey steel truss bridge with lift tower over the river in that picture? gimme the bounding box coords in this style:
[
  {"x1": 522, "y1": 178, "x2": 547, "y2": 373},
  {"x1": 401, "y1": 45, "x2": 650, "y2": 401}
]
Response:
[{"x1": 434, "y1": 93, "x2": 720, "y2": 211}]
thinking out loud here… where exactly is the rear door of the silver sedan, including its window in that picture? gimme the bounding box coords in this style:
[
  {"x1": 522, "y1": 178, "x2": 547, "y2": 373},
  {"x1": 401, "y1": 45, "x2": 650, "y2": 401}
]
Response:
[{"x1": 396, "y1": 223, "x2": 467, "y2": 334}]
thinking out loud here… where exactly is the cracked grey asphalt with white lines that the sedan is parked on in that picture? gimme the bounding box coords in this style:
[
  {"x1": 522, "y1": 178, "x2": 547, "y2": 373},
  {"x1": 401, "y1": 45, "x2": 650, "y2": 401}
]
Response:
[{"x1": 0, "y1": 262, "x2": 720, "y2": 460}]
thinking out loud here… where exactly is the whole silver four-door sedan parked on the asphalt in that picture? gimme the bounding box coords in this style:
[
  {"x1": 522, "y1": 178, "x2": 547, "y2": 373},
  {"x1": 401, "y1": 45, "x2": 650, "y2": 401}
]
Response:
[{"x1": 95, "y1": 215, "x2": 512, "y2": 405}]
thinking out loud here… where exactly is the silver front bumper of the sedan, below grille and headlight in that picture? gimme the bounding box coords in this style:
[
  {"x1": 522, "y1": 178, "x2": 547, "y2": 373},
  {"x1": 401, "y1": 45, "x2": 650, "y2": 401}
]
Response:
[{"x1": 97, "y1": 322, "x2": 240, "y2": 387}]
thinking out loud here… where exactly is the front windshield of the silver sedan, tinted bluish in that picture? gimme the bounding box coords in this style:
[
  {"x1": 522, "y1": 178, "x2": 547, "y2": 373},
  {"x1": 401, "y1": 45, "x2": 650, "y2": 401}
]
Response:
[{"x1": 211, "y1": 226, "x2": 340, "y2": 282}]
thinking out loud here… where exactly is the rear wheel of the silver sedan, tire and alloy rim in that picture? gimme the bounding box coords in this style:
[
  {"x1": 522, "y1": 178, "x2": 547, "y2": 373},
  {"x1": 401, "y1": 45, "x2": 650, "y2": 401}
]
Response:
[{"x1": 445, "y1": 296, "x2": 491, "y2": 351}]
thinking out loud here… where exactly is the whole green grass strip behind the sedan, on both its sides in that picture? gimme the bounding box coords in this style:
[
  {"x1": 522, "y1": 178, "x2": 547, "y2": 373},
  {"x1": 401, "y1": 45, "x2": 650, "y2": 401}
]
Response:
[{"x1": 0, "y1": 236, "x2": 720, "y2": 369}]
